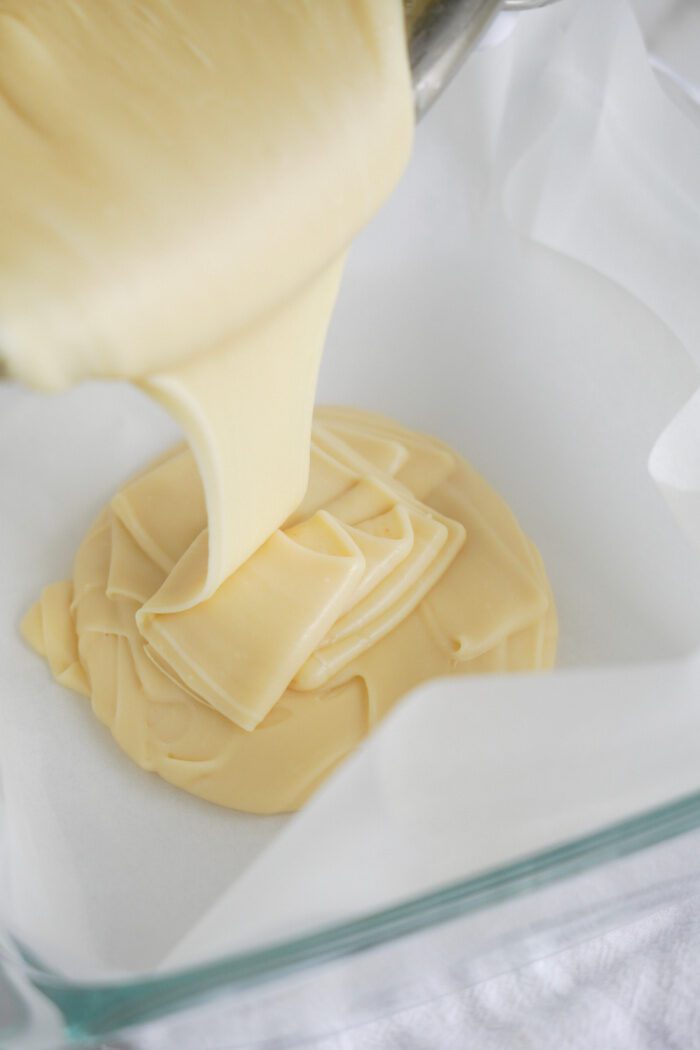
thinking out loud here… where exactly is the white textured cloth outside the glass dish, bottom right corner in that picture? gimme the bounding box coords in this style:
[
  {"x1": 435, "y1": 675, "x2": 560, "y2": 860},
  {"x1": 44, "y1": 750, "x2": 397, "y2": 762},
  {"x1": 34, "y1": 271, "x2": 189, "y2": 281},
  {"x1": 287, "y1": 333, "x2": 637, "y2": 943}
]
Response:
[{"x1": 313, "y1": 897, "x2": 700, "y2": 1050}]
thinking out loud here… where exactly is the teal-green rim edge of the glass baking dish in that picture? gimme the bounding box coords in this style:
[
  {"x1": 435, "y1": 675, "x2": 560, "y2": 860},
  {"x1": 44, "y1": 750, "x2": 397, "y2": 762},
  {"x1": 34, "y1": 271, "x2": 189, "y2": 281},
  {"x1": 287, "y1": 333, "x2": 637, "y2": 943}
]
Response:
[{"x1": 2, "y1": 792, "x2": 700, "y2": 1045}]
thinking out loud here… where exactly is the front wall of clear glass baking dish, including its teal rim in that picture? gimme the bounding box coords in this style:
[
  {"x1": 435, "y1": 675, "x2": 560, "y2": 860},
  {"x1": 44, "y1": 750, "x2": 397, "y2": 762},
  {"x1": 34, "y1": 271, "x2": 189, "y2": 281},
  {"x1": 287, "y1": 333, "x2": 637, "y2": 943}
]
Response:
[{"x1": 0, "y1": 795, "x2": 700, "y2": 1050}]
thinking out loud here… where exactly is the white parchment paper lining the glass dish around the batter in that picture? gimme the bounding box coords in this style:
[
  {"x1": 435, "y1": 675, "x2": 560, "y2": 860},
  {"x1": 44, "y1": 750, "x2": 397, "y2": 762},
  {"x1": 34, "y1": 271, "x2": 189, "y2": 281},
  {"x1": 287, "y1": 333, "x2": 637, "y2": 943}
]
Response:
[{"x1": 0, "y1": 0, "x2": 700, "y2": 979}]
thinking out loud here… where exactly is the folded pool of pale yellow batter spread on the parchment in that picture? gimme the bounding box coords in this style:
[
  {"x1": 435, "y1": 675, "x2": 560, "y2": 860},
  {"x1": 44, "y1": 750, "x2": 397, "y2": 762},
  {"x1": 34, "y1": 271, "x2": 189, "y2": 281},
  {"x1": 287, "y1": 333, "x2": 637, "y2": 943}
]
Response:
[{"x1": 23, "y1": 408, "x2": 556, "y2": 813}]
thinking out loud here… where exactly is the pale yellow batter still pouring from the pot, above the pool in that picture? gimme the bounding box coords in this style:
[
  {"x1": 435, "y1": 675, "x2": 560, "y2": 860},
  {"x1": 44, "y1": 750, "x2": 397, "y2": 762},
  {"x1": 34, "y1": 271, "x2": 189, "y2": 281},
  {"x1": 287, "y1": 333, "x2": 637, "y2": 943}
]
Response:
[{"x1": 0, "y1": 0, "x2": 412, "y2": 606}]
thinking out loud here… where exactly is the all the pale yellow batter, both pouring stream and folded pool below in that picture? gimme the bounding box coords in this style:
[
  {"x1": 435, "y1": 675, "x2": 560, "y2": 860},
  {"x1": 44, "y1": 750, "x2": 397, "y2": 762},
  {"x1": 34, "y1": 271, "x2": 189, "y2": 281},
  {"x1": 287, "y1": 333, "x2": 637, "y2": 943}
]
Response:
[{"x1": 0, "y1": 0, "x2": 556, "y2": 813}]
